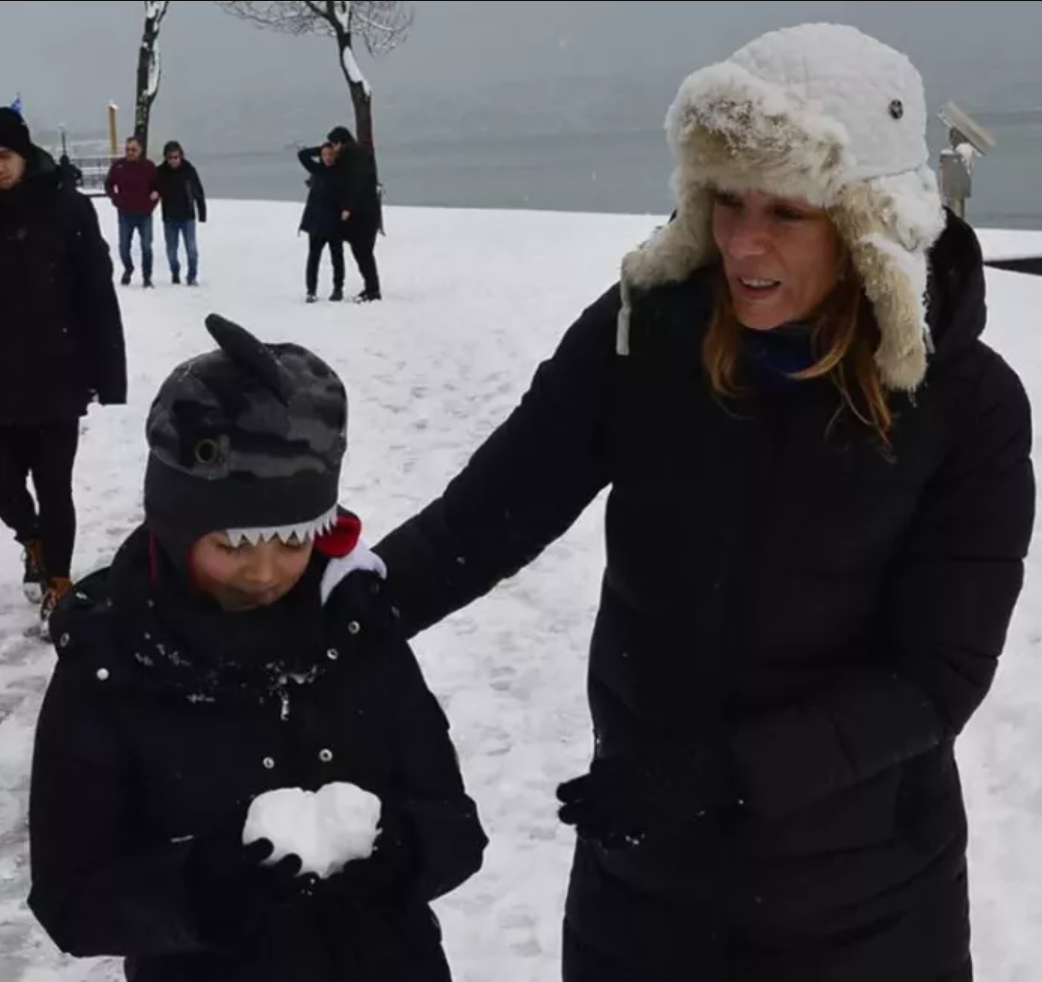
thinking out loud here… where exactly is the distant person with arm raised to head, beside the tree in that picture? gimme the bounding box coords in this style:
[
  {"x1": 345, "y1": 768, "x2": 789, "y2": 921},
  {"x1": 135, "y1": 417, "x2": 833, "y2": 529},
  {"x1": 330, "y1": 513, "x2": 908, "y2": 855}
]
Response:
[{"x1": 297, "y1": 143, "x2": 350, "y2": 303}]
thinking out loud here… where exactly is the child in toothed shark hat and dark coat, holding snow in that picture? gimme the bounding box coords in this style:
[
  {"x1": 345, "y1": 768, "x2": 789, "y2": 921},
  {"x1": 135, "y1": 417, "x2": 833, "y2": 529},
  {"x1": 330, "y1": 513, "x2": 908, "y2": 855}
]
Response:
[{"x1": 29, "y1": 317, "x2": 488, "y2": 982}]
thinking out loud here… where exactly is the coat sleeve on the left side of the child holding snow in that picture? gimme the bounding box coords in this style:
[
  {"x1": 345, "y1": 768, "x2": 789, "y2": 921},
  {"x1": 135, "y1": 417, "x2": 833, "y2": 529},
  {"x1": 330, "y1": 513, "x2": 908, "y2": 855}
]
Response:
[{"x1": 28, "y1": 662, "x2": 202, "y2": 958}]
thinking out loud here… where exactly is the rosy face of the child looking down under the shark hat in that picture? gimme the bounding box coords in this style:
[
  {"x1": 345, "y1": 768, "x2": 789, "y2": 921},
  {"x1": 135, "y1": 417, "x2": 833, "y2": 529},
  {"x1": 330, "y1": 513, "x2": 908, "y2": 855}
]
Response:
[{"x1": 190, "y1": 532, "x2": 314, "y2": 613}]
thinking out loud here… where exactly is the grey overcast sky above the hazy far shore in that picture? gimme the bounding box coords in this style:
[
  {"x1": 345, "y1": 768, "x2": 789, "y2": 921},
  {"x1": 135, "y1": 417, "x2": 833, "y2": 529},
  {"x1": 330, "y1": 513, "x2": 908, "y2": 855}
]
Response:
[{"x1": 0, "y1": 0, "x2": 1042, "y2": 145}]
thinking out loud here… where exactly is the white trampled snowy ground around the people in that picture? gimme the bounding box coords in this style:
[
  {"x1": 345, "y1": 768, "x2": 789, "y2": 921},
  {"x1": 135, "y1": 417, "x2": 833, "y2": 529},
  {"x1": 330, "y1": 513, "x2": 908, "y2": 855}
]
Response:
[{"x1": 0, "y1": 202, "x2": 1042, "y2": 982}]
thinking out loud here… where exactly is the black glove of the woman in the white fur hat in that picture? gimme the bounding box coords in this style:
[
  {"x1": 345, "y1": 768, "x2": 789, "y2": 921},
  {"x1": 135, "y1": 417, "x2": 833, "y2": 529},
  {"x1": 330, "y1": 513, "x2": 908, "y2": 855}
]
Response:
[{"x1": 557, "y1": 747, "x2": 730, "y2": 849}]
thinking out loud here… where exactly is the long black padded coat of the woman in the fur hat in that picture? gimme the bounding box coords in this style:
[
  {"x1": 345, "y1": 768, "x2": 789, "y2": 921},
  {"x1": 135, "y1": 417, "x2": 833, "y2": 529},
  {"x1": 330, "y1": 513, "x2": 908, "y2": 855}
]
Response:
[{"x1": 376, "y1": 211, "x2": 1035, "y2": 982}]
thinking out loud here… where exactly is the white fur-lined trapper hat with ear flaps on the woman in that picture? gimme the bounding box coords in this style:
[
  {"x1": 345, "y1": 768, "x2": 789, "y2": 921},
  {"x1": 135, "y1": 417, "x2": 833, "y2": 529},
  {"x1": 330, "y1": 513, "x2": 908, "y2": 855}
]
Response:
[{"x1": 619, "y1": 24, "x2": 945, "y2": 392}]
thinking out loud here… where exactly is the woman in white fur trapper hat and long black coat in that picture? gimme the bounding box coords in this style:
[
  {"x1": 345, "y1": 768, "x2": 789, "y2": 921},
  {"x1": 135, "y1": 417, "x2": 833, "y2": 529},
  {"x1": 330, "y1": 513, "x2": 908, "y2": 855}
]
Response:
[{"x1": 377, "y1": 25, "x2": 1035, "y2": 982}]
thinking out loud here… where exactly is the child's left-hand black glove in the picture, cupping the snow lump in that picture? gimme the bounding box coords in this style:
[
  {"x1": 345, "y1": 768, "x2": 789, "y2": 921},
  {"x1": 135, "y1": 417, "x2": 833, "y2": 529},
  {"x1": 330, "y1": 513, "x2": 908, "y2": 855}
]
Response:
[{"x1": 184, "y1": 808, "x2": 318, "y2": 939}]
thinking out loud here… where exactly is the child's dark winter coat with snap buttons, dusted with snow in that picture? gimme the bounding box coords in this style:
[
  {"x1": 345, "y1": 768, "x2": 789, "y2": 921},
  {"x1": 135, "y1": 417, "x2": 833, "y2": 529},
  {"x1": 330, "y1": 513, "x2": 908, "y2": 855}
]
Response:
[{"x1": 29, "y1": 530, "x2": 487, "y2": 982}]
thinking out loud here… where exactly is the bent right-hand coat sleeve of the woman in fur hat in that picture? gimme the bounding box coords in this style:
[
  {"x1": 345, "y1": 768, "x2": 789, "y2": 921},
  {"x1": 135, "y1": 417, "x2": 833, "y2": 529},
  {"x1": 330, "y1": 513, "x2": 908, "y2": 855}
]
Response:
[{"x1": 733, "y1": 355, "x2": 1035, "y2": 817}]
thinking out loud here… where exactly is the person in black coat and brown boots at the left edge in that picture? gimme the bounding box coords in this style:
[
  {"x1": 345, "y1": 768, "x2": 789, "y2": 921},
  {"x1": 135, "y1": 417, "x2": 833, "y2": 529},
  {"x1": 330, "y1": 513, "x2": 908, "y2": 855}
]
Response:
[{"x1": 0, "y1": 108, "x2": 127, "y2": 629}]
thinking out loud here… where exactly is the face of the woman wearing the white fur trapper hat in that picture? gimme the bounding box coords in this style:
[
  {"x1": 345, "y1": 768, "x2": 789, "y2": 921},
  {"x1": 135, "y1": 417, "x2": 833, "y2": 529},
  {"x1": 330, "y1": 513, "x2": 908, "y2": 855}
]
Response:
[{"x1": 713, "y1": 191, "x2": 842, "y2": 330}]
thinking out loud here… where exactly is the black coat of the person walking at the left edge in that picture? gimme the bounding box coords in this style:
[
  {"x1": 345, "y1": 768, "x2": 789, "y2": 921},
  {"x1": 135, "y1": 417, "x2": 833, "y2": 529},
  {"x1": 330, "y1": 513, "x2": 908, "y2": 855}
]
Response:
[{"x1": 0, "y1": 151, "x2": 127, "y2": 425}]
